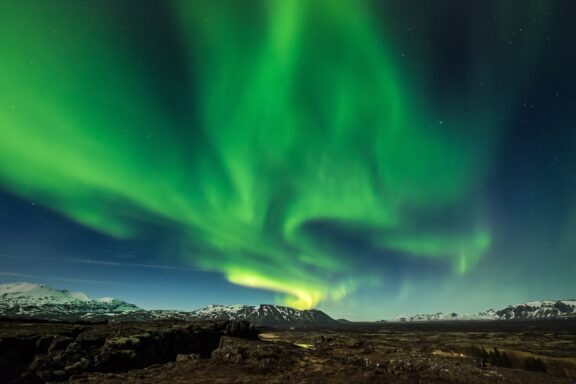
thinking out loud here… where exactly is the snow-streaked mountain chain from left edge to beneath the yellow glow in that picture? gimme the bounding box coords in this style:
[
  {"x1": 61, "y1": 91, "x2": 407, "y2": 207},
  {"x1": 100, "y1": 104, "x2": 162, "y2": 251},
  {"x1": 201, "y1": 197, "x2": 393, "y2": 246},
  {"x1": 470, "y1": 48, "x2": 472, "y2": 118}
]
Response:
[{"x1": 0, "y1": 283, "x2": 340, "y2": 327}]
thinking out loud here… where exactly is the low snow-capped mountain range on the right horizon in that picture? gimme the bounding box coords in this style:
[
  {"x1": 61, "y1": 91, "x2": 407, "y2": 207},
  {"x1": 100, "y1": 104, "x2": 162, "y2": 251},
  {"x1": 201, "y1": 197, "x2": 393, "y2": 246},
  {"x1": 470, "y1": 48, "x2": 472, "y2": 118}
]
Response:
[{"x1": 391, "y1": 300, "x2": 576, "y2": 322}]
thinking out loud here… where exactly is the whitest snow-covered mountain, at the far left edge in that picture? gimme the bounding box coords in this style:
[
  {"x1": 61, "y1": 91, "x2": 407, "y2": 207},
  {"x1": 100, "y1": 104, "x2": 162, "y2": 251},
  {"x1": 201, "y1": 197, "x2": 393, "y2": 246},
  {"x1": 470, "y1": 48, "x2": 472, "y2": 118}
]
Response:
[{"x1": 0, "y1": 283, "x2": 142, "y2": 320}]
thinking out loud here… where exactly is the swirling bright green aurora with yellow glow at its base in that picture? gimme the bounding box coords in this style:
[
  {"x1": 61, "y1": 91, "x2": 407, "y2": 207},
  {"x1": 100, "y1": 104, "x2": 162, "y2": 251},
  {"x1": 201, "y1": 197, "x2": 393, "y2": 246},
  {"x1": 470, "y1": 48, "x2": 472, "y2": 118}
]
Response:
[{"x1": 0, "y1": 0, "x2": 542, "y2": 308}]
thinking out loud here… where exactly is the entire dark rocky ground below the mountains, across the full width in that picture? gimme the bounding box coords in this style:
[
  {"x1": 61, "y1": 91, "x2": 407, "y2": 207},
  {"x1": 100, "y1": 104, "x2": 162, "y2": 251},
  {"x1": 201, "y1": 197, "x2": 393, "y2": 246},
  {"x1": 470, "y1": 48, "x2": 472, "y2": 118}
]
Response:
[{"x1": 0, "y1": 321, "x2": 576, "y2": 384}]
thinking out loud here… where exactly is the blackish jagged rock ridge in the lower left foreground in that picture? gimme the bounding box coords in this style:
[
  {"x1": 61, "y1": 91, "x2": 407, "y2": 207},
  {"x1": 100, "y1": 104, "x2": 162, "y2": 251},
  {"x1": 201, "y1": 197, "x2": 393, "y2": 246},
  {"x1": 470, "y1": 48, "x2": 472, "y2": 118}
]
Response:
[{"x1": 0, "y1": 321, "x2": 258, "y2": 383}]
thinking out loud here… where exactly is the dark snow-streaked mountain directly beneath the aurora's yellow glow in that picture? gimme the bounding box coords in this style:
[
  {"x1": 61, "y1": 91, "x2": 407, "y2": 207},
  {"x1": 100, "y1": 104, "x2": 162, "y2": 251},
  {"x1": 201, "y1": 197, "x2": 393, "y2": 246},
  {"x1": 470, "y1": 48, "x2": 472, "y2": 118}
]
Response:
[{"x1": 184, "y1": 304, "x2": 338, "y2": 326}]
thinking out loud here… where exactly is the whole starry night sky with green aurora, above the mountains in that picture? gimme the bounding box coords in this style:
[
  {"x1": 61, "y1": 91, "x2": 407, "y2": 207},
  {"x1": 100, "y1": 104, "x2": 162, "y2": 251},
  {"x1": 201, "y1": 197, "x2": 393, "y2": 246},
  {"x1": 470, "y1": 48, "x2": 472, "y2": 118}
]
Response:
[{"x1": 0, "y1": 0, "x2": 576, "y2": 320}]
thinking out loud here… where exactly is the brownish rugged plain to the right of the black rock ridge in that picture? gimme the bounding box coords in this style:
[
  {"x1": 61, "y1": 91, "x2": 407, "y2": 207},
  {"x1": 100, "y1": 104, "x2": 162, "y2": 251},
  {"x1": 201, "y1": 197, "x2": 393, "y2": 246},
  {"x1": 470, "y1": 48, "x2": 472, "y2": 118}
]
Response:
[{"x1": 70, "y1": 322, "x2": 576, "y2": 384}]
